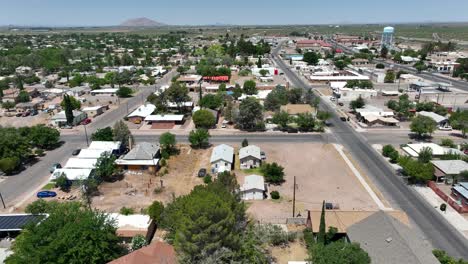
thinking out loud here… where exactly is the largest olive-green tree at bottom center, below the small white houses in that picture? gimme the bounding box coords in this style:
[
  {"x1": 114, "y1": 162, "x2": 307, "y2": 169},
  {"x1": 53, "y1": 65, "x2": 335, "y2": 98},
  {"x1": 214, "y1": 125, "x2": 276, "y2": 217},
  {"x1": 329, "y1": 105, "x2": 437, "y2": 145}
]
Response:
[{"x1": 162, "y1": 181, "x2": 245, "y2": 263}]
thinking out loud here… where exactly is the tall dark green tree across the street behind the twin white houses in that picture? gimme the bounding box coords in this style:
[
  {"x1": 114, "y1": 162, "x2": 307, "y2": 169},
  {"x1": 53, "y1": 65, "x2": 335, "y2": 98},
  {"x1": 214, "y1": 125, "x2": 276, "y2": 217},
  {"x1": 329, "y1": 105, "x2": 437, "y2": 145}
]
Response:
[{"x1": 236, "y1": 97, "x2": 263, "y2": 130}]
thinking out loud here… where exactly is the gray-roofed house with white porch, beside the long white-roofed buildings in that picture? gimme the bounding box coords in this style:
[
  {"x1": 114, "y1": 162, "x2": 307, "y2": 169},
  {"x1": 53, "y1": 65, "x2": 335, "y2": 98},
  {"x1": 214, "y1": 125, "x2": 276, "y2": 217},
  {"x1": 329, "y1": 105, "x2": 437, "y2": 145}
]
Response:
[{"x1": 115, "y1": 142, "x2": 161, "y2": 172}]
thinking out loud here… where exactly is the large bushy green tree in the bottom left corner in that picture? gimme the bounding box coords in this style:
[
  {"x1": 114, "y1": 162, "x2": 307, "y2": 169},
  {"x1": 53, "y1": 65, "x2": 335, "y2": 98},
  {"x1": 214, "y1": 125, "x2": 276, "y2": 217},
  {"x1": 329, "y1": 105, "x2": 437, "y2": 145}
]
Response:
[{"x1": 5, "y1": 202, "x2": 124, "y2": 264}]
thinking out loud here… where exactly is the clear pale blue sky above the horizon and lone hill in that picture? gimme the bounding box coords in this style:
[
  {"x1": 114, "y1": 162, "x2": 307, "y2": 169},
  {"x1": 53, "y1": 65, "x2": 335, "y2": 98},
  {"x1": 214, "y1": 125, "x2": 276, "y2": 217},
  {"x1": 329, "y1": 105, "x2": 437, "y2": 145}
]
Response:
[{"x1": 0, "y1": 0, "x2": 468, "y2": 26}]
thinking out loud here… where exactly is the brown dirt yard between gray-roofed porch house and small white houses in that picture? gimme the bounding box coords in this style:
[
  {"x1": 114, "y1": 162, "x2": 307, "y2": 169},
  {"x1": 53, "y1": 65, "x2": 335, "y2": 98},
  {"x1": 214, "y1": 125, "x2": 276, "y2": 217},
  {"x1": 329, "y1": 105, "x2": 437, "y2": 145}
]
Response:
[{"x1": 93, "y1": 146, "x2": 207, "y2": 212}]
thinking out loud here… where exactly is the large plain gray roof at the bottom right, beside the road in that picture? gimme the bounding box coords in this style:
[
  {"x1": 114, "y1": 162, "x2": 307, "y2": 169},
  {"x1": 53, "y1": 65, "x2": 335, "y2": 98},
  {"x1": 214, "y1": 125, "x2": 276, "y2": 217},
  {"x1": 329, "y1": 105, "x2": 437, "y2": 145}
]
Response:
[{"x1": 347, "y1": 211, "x2": 440, "y2": 264}]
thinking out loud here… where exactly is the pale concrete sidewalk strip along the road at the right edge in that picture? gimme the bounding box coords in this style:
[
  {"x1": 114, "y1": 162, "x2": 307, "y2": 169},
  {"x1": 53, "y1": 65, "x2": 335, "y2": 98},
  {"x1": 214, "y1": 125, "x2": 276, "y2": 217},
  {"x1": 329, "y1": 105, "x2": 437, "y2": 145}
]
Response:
[{"x1": 412, "y1": 186, "x2": 468, "y2": 239}]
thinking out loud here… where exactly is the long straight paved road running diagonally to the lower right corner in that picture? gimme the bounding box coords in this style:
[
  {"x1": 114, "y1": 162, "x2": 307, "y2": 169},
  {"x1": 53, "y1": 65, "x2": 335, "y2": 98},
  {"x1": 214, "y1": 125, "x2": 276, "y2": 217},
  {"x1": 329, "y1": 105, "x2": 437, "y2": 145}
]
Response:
[{"x1": 273, "y1": 46, "x2": 468, "y2": 259}]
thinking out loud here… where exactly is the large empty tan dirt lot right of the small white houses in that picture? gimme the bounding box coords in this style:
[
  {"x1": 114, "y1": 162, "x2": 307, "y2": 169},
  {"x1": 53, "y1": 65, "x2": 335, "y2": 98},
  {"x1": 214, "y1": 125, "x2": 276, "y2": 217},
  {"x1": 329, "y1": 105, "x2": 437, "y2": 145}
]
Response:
[{"x1": 241, "y1": 143, "x2": 378, "y2": 222}]
